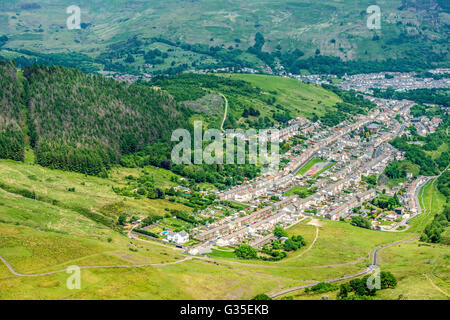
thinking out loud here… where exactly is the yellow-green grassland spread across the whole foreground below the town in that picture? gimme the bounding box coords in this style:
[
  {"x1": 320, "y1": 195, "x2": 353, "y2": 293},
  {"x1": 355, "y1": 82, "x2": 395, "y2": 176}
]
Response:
[{"x1": 0, "y1": 161, "x2": 448, "y2": 299}]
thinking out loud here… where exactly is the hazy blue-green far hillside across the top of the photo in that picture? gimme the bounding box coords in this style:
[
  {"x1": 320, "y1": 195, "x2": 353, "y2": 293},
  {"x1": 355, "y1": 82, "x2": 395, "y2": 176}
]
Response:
[{"x1": 0, "y1": 0, "x2": 450, "y2": 74}]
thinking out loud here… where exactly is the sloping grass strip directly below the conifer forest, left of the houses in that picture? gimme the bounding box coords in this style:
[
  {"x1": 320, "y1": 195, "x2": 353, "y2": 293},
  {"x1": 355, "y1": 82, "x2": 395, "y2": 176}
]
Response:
[{"x1": 0, "y1": 160, "x2": 192, "y2": 228}]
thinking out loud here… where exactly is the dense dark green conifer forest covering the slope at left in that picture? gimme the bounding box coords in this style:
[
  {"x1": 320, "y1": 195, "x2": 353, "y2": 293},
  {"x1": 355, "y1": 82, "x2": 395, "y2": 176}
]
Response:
[{"x1": 0, "y1": 64, "x2": 184, "y2": 174}]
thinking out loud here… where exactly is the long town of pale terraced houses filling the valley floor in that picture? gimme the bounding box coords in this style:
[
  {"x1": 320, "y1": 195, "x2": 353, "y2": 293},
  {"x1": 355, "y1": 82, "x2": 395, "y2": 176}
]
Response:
[{"x1": 132, "y1": 86, "x2": 441, "y2": 255}]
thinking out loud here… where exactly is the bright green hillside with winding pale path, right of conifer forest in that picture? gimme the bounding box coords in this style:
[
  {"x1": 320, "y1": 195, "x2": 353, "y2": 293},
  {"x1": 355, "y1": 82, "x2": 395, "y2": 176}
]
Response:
[{"x1": 151, "y1": 74, "x2": 342, "y2": 129}]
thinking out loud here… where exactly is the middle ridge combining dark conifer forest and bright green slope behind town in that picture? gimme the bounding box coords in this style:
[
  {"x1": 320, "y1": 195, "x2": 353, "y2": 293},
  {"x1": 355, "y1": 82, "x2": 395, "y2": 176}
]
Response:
[{"x1": 0, "y1": 61, "x2": 348, "y2": 176}]
